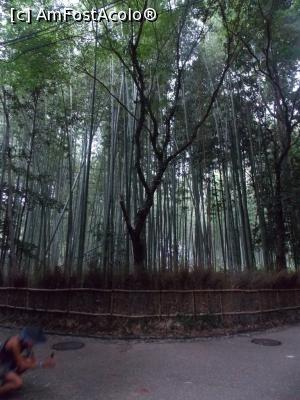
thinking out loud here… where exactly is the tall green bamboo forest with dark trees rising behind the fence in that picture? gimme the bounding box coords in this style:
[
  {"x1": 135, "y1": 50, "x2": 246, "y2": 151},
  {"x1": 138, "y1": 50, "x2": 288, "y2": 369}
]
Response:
[{"x1": 0, "y1": 0, "x2": 300, "y2": 286}]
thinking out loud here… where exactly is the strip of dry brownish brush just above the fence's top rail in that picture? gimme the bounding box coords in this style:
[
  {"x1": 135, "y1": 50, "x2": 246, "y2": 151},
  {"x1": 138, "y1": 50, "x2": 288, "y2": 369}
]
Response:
[{"x1": 6, "y1": 268, "x2": 300, "y2": 290}]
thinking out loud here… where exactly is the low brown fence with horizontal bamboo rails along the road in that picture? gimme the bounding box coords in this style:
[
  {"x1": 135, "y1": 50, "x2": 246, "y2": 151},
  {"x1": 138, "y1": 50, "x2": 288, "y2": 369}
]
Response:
[{"x1": 0, "y1": 287, "x2": 300, "y2": 319}]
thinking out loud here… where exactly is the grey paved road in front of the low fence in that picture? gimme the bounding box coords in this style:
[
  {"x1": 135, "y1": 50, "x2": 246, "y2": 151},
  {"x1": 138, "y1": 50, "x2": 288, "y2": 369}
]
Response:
[{"x1": 0, "y1": 325, "x2": 300, "y2": 400}]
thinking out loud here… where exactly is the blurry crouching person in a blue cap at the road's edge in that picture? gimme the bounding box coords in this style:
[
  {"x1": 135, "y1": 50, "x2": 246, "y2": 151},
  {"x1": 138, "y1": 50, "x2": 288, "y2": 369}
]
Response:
[{"x1": 0, "y1": 327, "x2": 55, "y2": 396}]
